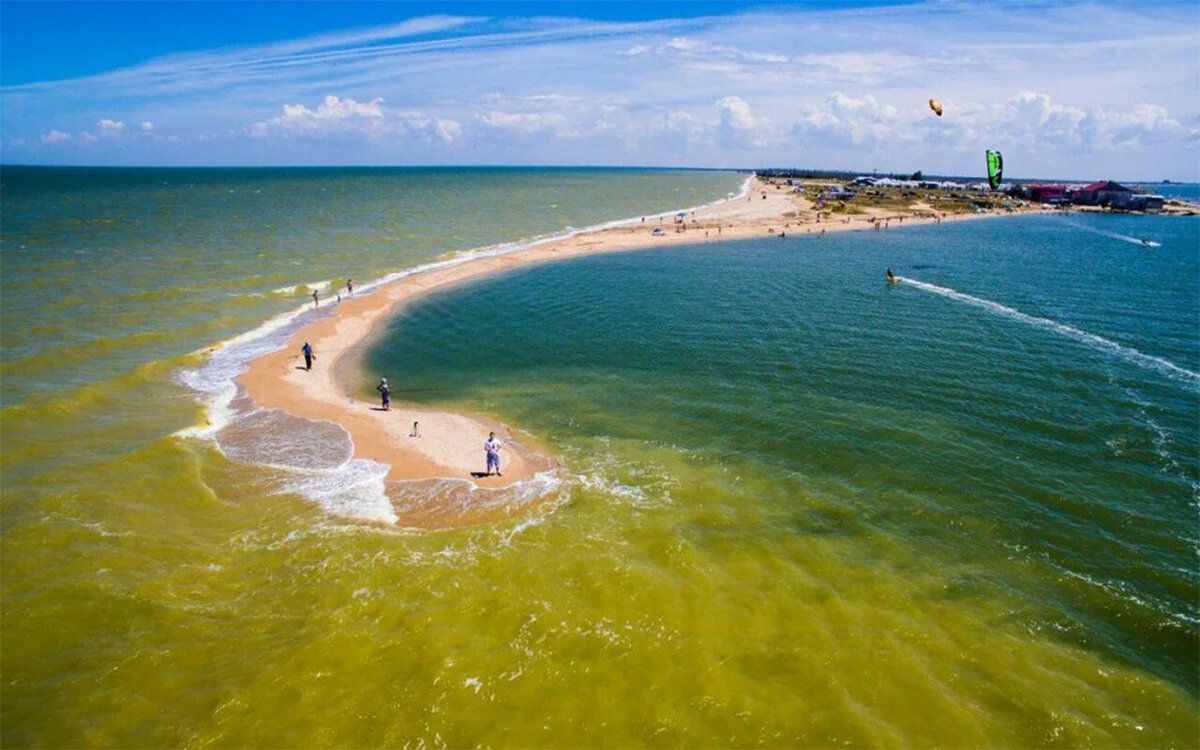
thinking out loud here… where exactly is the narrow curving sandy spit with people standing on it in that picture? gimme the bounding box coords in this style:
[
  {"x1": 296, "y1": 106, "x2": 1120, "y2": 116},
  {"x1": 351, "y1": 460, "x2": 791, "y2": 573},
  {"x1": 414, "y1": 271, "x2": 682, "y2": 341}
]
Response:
[{"x1": 236, "y1": 176, "x2": 1171, "y2": 529}]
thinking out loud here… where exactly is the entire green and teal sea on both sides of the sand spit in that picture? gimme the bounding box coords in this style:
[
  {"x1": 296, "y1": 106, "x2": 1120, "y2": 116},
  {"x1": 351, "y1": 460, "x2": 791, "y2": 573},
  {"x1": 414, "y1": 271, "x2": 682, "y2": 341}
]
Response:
[{"x1": 0, "y1": 167, "x2": 1200, "y2": 748}]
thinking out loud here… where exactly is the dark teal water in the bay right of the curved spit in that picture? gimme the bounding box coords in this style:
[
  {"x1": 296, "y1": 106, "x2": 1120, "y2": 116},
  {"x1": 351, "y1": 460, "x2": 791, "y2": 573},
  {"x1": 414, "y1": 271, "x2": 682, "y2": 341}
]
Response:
[{"x1": 370, "y1": 216, "x2": 1200, "y2": 729}]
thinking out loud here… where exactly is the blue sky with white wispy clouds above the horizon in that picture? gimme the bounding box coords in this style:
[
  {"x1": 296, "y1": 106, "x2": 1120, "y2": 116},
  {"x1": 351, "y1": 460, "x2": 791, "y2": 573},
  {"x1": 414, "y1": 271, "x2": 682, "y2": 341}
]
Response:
[{"x1": 0, "y1": 0, "x2": 1200, "y2": 181}]
